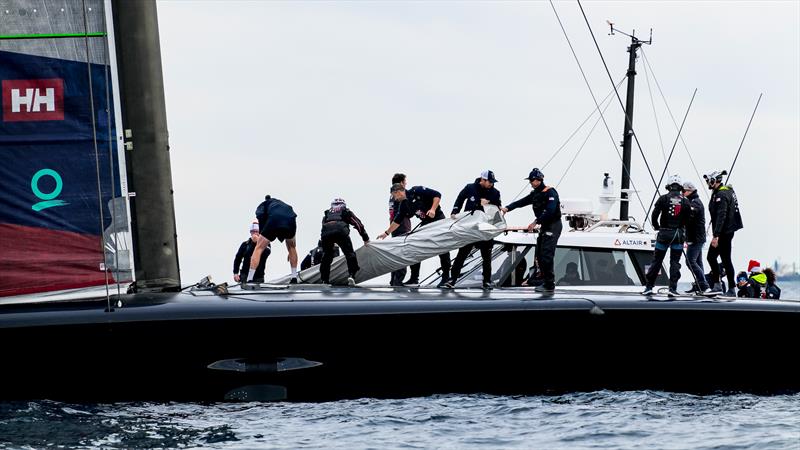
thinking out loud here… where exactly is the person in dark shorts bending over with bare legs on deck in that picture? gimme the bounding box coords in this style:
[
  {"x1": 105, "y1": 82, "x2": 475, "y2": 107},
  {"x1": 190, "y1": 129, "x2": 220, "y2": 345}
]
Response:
[{"x1": 252, "y1": 195, "x2": 297, "y2": 284}]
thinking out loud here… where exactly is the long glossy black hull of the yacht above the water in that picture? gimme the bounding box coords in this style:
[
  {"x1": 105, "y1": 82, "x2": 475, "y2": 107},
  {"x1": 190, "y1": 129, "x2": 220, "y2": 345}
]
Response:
[{"x1": 0, "y1": 289, "x2": 800, "y2": 401}]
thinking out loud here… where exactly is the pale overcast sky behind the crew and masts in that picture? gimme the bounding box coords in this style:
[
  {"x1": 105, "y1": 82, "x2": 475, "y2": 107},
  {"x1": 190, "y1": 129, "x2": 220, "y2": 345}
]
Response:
[{"x1": 153, "y1": 0, "x2": 800, "y2": 284}]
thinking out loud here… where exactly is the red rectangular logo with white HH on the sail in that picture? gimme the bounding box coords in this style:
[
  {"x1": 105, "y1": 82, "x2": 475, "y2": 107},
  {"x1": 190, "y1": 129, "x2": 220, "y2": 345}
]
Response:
[{"x1": 3, "y1": 78, "x2": 64, "y2": 122}]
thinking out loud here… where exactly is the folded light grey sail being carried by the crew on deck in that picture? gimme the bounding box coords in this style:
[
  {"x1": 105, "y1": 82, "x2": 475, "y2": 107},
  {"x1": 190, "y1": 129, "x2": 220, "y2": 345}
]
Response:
[{"x1": 272, "y1": 205, "x2": 506, "y2": 284}]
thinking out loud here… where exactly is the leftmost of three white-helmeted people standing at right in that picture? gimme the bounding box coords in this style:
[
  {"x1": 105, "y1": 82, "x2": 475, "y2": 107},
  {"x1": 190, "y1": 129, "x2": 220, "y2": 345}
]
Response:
[{"x1": 642, "y1": 175, "x2": 691, "y2": 297}]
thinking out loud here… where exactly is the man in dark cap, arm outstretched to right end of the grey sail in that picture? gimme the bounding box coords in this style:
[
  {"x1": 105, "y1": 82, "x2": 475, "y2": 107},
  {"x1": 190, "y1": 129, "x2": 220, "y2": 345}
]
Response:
[{"x1": 501, "y1": 168, "x2": 562, "y2": 293}]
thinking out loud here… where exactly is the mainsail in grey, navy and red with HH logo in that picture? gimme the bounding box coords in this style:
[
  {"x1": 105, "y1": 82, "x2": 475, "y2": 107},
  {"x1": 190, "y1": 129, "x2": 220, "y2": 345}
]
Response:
[{"x1": 0, "y1": 0, "x2": 131, "y2": 296}]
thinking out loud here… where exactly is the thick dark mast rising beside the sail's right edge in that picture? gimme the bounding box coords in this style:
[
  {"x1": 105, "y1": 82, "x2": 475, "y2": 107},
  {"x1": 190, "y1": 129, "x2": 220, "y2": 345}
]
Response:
[{"x1": 111, "y1": 0, "x2": 180, "y2": 292}]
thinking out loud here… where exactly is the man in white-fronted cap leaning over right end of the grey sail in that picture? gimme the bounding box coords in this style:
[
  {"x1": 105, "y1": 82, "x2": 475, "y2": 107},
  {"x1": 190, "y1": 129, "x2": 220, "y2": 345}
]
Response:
[{"x1": 443, "y1": 170, "x2": 501, "y2": 289}]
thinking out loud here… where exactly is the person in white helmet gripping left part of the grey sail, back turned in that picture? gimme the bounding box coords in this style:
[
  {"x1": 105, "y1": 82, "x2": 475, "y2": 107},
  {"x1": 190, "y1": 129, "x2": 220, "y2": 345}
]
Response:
[{"x1": 319, "y1": 198, "x2": 369, "y2": 286}]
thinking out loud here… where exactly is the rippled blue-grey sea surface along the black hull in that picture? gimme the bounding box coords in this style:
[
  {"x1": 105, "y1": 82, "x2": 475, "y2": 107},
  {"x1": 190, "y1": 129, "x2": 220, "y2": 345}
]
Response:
[{"x1": 0, "y1": 282, "x2": 800, "y2": 450}]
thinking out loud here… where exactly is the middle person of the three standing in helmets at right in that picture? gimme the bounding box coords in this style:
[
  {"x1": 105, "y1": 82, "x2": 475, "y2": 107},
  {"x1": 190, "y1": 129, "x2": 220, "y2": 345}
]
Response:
[{"x1": 683, "y1": 181, "x2": 709, "y2": 294}]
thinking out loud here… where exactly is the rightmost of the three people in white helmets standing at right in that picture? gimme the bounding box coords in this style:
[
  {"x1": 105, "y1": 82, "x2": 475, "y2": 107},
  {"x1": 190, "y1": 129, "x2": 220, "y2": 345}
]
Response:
[{"x1": 703, "y1": 170, "x2": 744, "y2": 297}]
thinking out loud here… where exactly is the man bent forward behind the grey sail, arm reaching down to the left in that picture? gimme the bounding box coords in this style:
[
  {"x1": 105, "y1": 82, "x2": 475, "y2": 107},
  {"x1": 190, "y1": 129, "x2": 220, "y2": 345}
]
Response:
[{"x1": 378, "y1": 183, "x2": 450, "y2": 287}]
